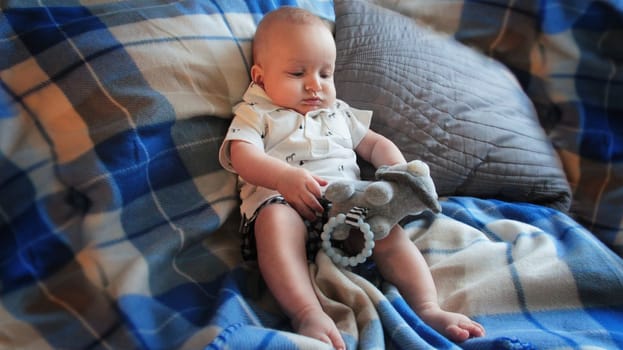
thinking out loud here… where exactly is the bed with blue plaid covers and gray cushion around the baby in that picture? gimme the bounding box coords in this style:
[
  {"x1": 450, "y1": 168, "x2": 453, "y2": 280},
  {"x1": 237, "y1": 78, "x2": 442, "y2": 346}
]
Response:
[{"x1": 0, "y1": 0, "x2": 623, "y2": 349}]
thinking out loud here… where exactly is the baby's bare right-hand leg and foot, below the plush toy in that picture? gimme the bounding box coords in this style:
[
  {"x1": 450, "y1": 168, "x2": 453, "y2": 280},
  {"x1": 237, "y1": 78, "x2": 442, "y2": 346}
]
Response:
[{"x1": 373, "y1": 225, "x2": 485, "y2": 342}]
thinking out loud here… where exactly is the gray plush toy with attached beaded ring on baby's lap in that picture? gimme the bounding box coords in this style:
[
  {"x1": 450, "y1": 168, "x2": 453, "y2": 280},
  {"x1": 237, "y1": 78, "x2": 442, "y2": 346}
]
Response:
[{"x1": 321, "y1": 160, "x2": 441, "y2": 266}]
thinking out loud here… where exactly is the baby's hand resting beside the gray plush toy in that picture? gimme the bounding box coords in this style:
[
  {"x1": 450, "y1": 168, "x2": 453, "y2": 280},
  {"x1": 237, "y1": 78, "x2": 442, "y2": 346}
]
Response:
[{"x1": 277, "y1": 168, "x2": 327, "y2": 221}]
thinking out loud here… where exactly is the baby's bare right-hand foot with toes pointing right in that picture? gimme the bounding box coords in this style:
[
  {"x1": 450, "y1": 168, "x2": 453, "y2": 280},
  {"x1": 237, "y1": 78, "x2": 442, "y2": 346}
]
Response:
[{"x1": 416, "y1": 303, "x2": 485, "y2": 342}]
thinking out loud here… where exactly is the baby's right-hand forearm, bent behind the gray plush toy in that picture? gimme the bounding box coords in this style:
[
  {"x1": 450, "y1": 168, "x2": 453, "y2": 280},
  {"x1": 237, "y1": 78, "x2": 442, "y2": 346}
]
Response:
[{"x1": 355, "y1": 130, "x2": 407, "y2": 168}]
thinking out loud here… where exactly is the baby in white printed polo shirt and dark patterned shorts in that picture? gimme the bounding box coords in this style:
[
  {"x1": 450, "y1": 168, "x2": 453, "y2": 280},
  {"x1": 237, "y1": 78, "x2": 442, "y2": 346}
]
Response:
[{"x1": 220, "y1": 7, "x2": 484, "y2": 349}]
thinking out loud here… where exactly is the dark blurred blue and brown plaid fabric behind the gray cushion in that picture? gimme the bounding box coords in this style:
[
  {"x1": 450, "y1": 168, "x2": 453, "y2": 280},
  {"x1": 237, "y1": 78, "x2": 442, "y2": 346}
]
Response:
[{"x1": 374, "y1": 0, "x2": 623, "y2": 256}]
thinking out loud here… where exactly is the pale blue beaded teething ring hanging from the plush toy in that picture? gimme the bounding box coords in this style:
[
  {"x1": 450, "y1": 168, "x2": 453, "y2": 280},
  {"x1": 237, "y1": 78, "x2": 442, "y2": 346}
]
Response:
[{"x1": 320, "y1": 213, "x2": 374, "y2": 267}]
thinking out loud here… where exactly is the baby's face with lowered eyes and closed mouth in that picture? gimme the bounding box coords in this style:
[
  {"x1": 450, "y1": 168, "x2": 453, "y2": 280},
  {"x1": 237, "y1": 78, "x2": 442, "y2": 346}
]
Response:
[{"x1": 254, "y1": 24, "x2": 336, "y2": 114}]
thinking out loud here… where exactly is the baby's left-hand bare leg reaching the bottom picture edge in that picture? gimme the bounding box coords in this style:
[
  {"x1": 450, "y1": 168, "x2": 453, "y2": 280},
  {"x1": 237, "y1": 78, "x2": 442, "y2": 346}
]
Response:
[{"x1": 255, "y1": 204, "x2": 346, "y2": 349}]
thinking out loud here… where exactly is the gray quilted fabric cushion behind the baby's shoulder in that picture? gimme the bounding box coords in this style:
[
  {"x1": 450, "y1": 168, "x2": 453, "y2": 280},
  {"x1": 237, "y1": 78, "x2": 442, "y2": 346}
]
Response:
[{"x1": 335, "y1": 0, "x2": 571, "y2": 210}]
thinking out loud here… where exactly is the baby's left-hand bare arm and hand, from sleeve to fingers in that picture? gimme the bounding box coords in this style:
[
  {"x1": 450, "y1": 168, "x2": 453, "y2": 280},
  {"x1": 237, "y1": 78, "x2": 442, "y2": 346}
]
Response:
[{"x1": 230, "y1": 140, "x2": 327, "y2": 220}]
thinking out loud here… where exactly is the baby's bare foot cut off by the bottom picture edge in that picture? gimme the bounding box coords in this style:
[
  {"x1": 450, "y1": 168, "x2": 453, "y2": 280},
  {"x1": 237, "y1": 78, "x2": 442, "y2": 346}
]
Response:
[{"x1": 292, "y1": 308, "x2": 346, "y2": 350}]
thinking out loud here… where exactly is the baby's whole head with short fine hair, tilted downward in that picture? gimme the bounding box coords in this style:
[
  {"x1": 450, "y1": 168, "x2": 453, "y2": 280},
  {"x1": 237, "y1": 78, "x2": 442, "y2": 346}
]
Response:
[{"x1": 251, "y1": 7, "x2": 336, "y2": 114}]
